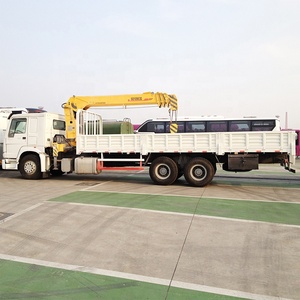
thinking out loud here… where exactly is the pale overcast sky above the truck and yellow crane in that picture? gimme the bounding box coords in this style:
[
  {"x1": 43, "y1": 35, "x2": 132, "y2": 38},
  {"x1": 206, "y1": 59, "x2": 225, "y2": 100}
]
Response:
[{"x1": 0, "y1": 0, "x2": 300, "y2": 128}]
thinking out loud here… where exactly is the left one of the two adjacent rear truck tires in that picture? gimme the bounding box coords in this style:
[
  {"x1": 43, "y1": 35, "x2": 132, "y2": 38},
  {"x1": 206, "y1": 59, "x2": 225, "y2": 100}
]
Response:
[{"x1": 149, "y1": 156, "x2": 178, "y2": 185}]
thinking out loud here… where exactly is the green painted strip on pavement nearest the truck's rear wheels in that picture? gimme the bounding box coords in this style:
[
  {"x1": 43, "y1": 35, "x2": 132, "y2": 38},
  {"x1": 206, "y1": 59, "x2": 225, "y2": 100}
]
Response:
[{"x1": 50, "y1": 191, "x2": 300, "y2": 225}]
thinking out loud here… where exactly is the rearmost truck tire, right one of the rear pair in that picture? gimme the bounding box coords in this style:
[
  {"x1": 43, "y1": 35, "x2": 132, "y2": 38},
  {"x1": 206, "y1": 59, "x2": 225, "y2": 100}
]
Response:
[{"x1": 184, "y1": 157, "x2": 215, "y2": 187}]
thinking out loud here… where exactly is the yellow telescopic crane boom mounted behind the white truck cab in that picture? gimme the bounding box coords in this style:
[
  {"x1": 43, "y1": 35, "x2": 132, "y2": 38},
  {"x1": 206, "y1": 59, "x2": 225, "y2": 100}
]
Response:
[{"x1": 62, "y1": 92, "x2": 178, "y2": 145}]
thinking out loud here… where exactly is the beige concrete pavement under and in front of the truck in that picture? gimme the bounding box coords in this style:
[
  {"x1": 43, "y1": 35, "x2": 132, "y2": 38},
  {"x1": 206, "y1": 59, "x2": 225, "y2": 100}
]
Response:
[{"x1": 0, "y1": 161, "x2": 300, "y2": 299}]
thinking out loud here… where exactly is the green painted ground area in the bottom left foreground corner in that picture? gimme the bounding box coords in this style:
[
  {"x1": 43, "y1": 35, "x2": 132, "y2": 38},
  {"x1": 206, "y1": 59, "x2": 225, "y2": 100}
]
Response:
[{"x1": 0, "y1": 260, "x2": 242, "y2": 300}]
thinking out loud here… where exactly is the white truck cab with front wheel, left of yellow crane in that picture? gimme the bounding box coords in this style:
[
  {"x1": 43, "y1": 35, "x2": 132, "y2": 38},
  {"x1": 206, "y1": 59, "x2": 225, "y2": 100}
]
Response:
[{"x1": 2, "y1": 113, "x2": 65, "y2": 178}]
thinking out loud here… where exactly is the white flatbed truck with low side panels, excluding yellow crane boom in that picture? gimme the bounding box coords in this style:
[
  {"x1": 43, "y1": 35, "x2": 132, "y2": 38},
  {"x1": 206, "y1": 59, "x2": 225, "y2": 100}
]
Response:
[{"x1": 2, "y1": 110, "x2": 296, "y2": 187}]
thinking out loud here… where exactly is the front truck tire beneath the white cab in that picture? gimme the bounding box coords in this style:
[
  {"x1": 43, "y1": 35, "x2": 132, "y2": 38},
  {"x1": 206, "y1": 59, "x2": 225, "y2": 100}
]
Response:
[{"x1": 19, "y1": 154, "x2": 42, "y2": 179}]
